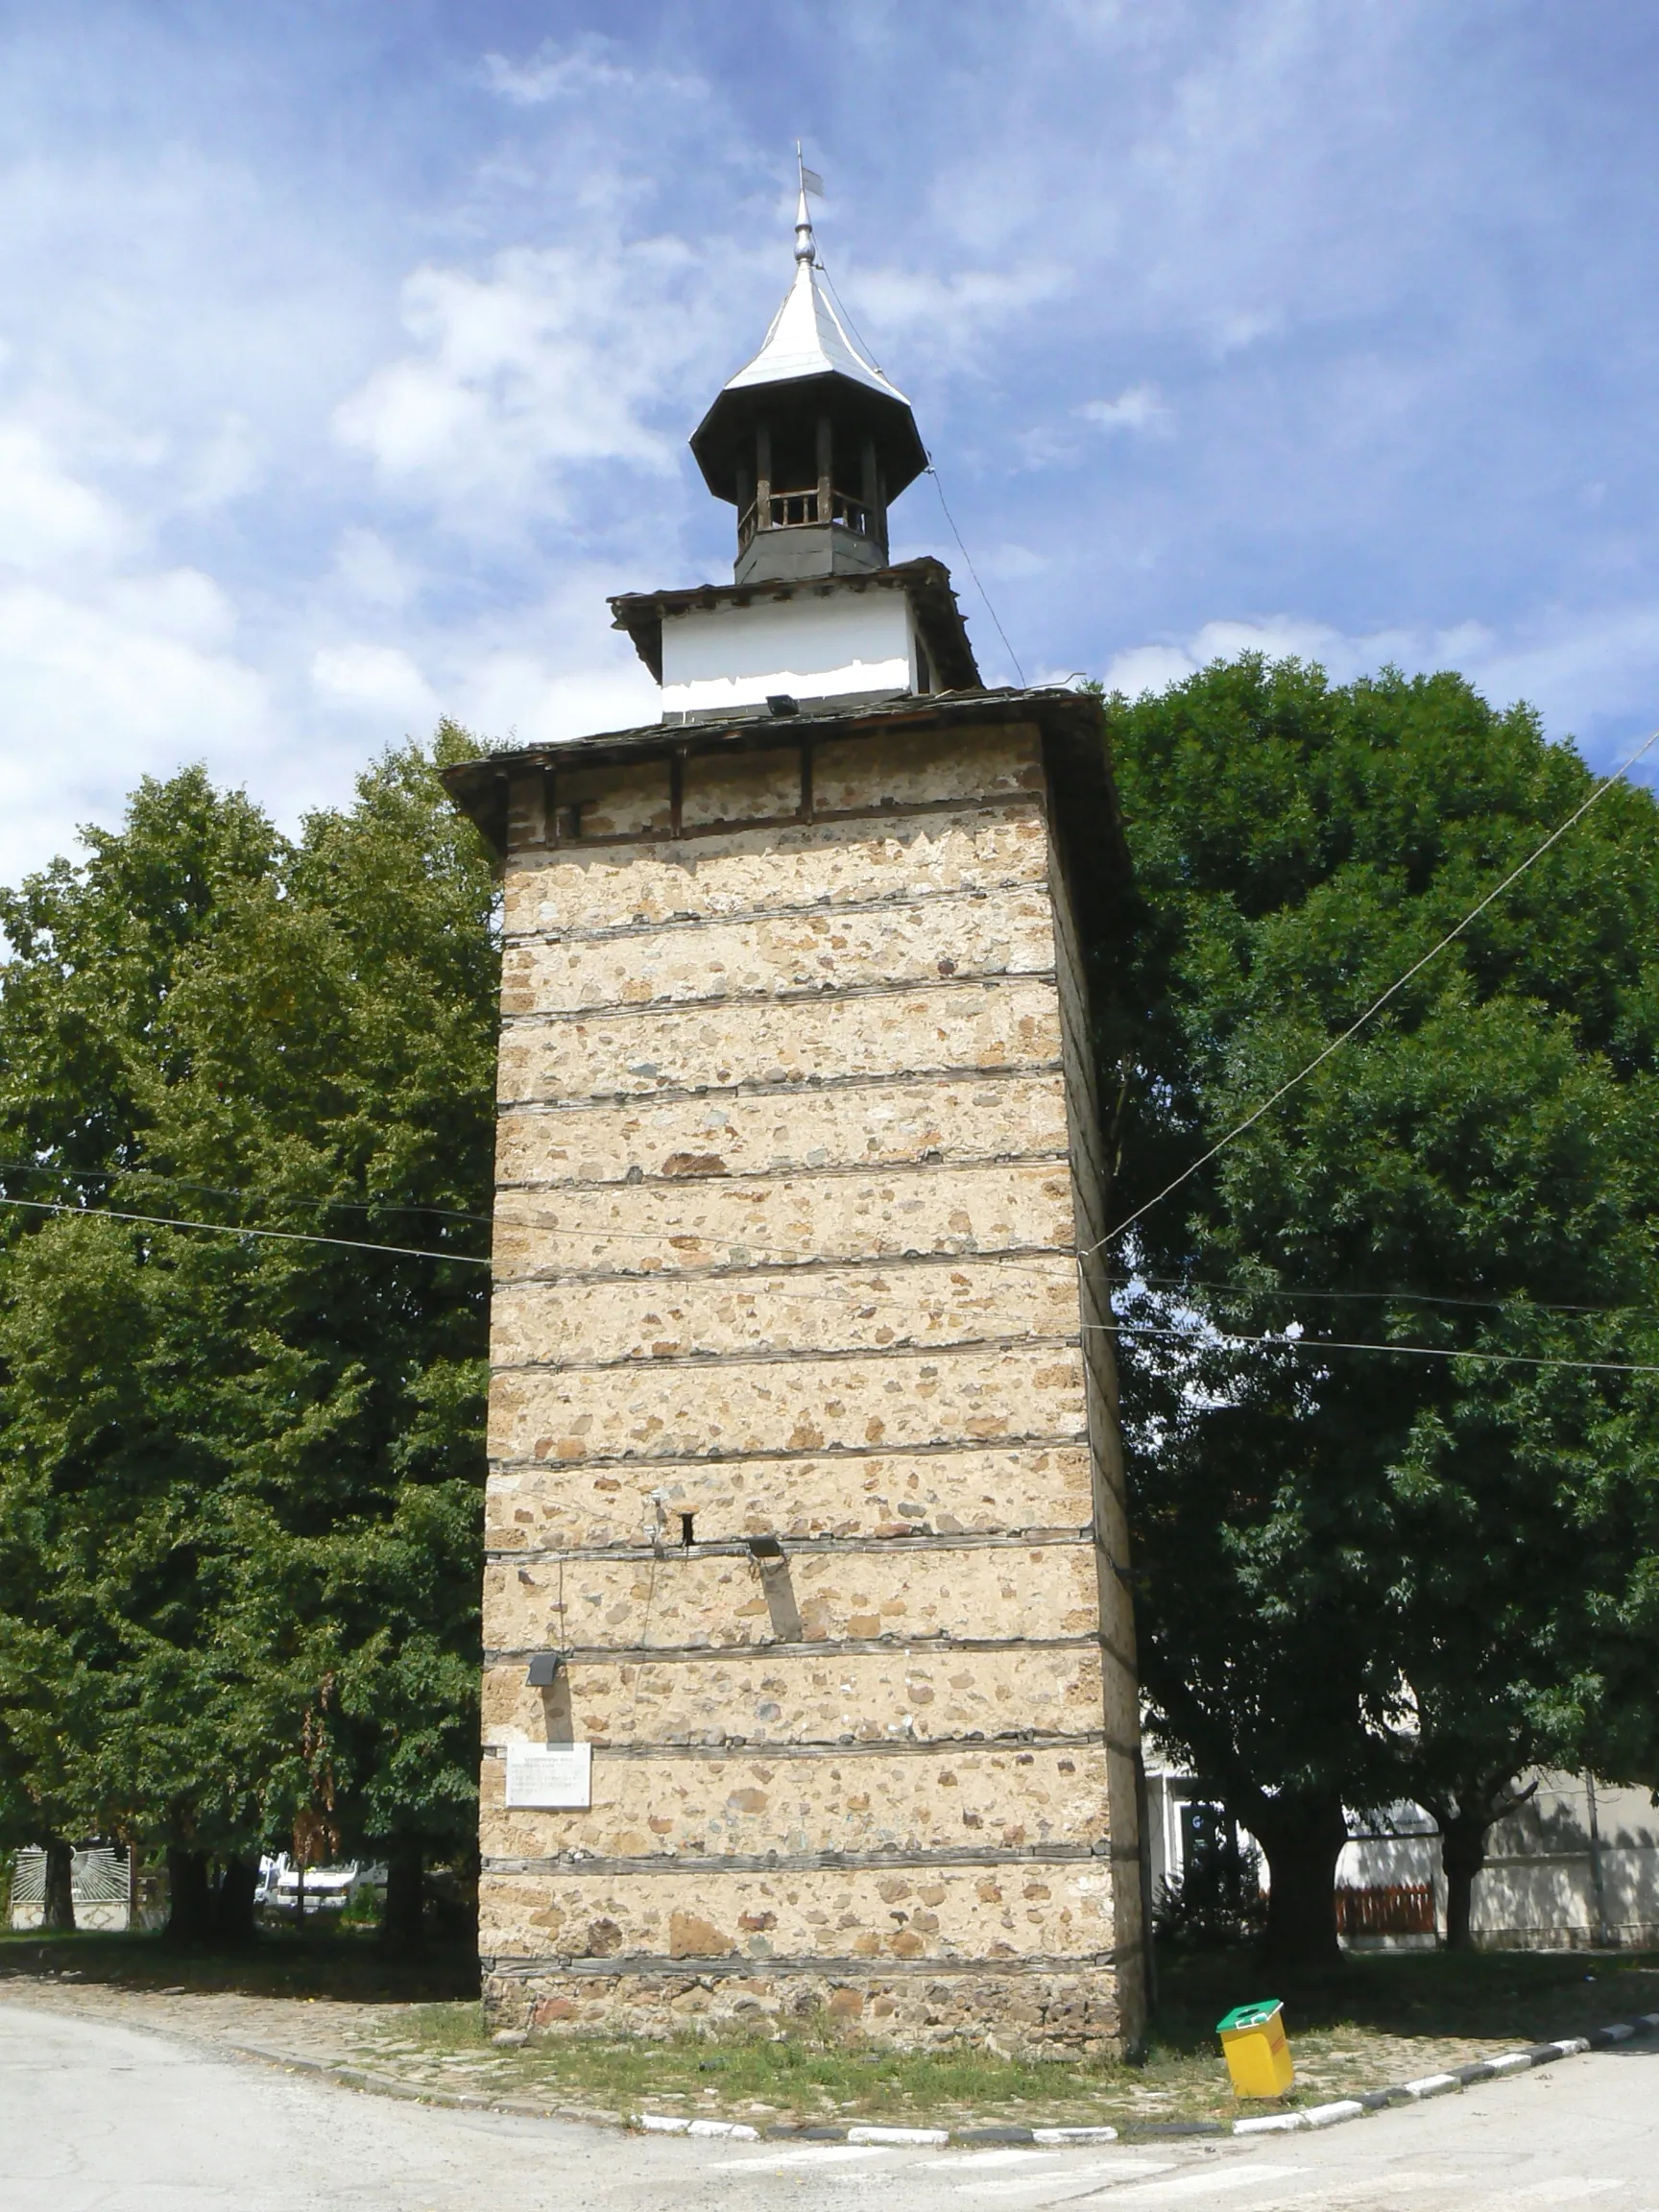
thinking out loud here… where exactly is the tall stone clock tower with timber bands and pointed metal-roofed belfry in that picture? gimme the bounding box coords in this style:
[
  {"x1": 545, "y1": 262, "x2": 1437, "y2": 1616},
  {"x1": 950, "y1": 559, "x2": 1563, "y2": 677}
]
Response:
[{"x1": 449, "y1": 172, "x2": 1143, "y2": 2053}]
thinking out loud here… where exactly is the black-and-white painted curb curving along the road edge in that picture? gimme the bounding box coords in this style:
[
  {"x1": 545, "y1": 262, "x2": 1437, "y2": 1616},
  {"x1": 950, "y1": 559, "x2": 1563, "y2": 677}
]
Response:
[{"x1": 219, "y1": 2013, "x2": 1659, "y2": 2150}]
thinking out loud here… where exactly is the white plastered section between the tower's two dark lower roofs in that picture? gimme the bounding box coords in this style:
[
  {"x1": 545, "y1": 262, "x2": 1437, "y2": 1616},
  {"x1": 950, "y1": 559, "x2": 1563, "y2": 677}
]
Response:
[{"x1": 661, "y1": 584, "x2": 916, "y2": 716}]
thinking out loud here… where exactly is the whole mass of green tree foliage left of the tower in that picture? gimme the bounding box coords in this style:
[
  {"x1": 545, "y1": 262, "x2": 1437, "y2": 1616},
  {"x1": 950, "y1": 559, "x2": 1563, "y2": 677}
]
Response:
[{"x1": 0, "y1": 726, "x2": 497, "y2": 1919}]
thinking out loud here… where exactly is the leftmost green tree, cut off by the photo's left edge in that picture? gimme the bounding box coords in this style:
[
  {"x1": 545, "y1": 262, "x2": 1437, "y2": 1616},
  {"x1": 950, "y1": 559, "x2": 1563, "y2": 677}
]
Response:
[{"x1": 0, "y1": 772, "x2": 278, "y2": 1919}]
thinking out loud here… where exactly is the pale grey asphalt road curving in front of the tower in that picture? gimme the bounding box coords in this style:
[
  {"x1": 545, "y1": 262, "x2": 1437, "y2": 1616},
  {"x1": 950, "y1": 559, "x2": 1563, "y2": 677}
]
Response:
[{"x1": 0, "y1": 2004, "x2": 1659, "y2": 2212}]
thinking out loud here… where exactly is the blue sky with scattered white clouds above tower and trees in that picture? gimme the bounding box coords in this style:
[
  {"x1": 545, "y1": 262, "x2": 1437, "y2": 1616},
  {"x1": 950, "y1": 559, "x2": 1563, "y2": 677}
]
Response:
[{"x1": 0, "y1": 0, "x2": 1659, "y2": 880}]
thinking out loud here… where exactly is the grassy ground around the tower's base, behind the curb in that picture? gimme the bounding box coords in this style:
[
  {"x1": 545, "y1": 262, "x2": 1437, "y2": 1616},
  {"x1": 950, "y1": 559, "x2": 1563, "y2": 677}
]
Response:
[{"x1": 15, "y1": 1922, "x2": 1659, "y2": 2128}]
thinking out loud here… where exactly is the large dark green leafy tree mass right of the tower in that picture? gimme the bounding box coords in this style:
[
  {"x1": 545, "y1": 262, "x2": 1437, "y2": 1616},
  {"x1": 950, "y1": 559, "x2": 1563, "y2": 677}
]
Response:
[{"x1": 1108, "y1": 660, "x2": 1659, "y2": 1958}]
